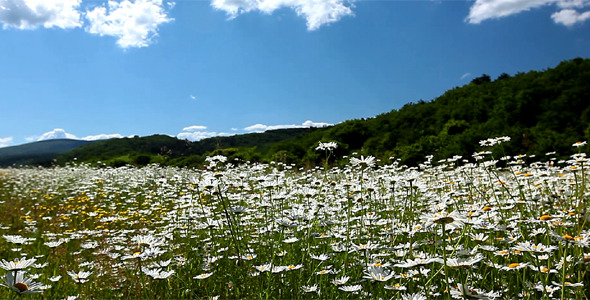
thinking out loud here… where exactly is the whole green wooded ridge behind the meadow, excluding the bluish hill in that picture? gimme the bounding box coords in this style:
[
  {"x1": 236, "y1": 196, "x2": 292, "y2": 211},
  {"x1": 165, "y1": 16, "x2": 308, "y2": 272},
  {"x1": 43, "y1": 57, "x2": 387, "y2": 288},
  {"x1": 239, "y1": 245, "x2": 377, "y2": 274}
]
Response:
[{"x1": 58, "y1": 58, "x2": 590, "y2": 167}]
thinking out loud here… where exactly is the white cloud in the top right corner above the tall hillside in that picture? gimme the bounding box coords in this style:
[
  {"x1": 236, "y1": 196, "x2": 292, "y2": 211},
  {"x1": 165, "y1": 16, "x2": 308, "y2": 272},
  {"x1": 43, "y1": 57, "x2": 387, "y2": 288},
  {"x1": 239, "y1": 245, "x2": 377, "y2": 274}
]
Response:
[{"x1": 465, "y1": 0, "x2": 590, "y2": 26}]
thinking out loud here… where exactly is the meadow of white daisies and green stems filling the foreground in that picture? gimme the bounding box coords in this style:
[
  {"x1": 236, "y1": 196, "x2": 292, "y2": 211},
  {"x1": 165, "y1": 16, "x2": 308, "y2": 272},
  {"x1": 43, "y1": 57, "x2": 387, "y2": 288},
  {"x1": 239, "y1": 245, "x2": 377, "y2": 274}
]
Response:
[{"x1": 0, "y1": 137, "x2": 590, "y2": 299}]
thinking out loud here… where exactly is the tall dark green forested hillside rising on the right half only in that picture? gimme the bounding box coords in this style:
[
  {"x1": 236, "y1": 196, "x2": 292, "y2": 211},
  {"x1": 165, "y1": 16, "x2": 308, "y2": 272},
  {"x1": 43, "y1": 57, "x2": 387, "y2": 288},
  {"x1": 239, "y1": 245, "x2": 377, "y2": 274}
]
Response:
[{"x1": 273, "y1": 58, "x2": 590, "y2": 164}]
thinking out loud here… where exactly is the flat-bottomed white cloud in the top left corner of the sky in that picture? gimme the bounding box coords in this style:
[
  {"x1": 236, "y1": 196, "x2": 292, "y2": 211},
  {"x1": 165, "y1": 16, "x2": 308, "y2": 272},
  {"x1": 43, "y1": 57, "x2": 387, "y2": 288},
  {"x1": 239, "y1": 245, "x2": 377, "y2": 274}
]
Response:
[{"x1": 0, "y1": 0, "x2": 82, "y2": 29}]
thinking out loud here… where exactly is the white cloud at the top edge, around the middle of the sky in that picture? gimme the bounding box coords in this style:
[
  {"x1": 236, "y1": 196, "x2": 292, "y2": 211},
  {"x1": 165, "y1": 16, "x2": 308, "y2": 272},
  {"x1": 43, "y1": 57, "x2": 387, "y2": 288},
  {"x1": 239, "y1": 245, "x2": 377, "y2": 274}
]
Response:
[{"x1": 211, "y1": 0, "x2": 354, "y2": 30}]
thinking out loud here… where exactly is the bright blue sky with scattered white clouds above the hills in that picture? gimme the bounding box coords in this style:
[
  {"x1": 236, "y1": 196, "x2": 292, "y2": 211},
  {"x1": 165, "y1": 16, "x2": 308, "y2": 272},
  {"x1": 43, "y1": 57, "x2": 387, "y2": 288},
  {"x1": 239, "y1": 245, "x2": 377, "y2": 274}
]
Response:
[{"x1": 0, "y1": 0, "x2": 590, "y2": 147}]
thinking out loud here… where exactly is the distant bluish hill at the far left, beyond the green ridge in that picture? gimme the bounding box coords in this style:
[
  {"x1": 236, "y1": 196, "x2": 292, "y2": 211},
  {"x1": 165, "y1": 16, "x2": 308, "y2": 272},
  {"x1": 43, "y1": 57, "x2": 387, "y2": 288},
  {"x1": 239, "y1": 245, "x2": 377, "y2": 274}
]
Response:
[{"x1": 0, "y1": 139, "x2": 91, "y2": 167}]
